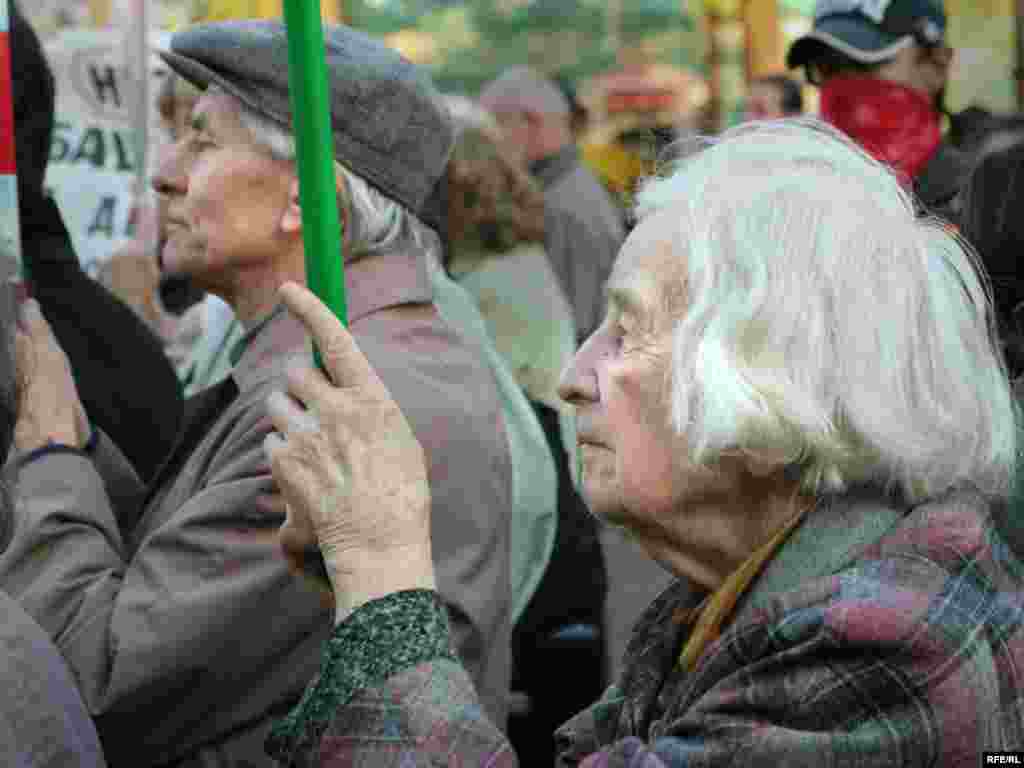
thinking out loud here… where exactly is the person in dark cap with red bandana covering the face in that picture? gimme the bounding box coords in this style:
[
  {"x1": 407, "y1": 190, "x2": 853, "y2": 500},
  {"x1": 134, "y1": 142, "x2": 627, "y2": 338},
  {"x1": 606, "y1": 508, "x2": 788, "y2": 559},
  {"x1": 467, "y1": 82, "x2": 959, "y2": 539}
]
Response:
[{"x1": 786, "y1": 0, "x2": 969, "y2": 219}]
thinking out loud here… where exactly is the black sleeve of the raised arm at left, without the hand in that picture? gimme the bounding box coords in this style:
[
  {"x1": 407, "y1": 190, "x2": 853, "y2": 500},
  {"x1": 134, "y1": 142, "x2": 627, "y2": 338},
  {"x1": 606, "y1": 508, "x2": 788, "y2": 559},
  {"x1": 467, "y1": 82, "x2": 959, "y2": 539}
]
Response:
[{"x1": 20, "y1": 199, "x2": 183, "y2": 480}]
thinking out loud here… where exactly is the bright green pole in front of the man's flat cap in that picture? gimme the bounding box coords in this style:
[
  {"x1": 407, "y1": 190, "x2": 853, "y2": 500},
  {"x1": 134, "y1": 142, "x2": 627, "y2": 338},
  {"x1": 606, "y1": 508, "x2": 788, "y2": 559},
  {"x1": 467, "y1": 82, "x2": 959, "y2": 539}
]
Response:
[{"x1": 285, "y1": 0, "x2": 348, "y2": 369}]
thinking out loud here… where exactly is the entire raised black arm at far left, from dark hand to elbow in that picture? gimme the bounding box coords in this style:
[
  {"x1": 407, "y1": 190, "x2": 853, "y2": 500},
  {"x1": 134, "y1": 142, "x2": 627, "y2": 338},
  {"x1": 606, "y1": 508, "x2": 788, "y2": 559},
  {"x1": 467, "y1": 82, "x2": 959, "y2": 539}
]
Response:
[{"x1": 8, "y1": 0, "x2": 182, "y2": 479}]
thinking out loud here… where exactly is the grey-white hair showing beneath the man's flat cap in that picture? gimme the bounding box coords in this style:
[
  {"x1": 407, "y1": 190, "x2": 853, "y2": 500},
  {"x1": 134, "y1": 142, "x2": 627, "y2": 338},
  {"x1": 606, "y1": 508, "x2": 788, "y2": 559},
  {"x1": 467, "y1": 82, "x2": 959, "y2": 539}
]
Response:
[{"x1": 227, "y1": 87, "x2": 440, "y2": 263}]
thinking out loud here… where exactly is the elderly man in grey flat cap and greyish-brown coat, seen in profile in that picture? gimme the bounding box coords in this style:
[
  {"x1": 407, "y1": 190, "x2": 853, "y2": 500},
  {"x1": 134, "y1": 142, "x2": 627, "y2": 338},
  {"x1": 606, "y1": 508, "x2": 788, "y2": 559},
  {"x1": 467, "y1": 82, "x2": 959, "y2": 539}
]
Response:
[{"x1": 0, "y1": 22, "x2": 510, "y2": 766}]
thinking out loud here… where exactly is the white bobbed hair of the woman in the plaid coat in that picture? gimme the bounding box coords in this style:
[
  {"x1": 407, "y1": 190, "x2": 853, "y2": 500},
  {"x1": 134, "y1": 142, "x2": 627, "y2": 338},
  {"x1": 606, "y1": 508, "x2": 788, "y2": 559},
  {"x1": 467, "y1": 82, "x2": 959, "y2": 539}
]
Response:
[{"x1": 637, "y1": 119, "x2": 1017, "y2": 502}]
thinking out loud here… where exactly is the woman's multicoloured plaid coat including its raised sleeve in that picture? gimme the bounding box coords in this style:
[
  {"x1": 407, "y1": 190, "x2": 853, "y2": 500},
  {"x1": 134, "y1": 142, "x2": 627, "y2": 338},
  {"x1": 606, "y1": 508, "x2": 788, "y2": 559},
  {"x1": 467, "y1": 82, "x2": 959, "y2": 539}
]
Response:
[{"x1": 276, "y1": 483, "x2": 1024, "y2": 768}]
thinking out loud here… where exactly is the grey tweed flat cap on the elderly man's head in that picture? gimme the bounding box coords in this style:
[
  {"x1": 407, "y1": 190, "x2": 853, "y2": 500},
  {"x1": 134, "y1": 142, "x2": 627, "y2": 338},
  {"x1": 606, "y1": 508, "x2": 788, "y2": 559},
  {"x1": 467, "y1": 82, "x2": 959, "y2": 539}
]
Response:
[{"x1": 160, "y1": 19, "x2": 455, "y2": 214}]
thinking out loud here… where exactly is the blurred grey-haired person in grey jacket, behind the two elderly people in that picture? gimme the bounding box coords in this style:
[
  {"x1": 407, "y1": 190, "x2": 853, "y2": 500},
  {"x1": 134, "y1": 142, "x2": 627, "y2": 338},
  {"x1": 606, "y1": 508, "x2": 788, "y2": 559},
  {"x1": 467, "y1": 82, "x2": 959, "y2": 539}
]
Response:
[{"x1": 479, "y1": 67, "x2": 626, "y2": 338}]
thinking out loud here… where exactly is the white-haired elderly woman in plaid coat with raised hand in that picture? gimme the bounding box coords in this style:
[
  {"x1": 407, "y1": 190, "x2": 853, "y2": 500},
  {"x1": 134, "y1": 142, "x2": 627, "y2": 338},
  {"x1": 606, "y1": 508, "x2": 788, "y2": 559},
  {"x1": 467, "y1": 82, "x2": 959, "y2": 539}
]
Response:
[{"x1": 267, "y1": 121, "x2": 1024, "y2": 768}]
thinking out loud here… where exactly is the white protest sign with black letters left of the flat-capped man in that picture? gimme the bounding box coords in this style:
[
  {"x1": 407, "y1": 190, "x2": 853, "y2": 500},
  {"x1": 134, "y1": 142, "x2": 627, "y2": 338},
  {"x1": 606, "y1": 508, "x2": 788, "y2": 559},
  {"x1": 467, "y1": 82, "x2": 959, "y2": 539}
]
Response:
[{"x1": 46, "y1": 30, "x2": 166, "y2": 273}]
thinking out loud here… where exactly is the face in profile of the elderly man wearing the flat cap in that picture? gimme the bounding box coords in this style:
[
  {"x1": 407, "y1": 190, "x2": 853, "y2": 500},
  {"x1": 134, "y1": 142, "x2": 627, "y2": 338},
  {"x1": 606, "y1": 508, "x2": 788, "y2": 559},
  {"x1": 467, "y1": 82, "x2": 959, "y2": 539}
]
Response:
[{"x1": 154, "y1": 89, "x2": 294, "y2": 293}]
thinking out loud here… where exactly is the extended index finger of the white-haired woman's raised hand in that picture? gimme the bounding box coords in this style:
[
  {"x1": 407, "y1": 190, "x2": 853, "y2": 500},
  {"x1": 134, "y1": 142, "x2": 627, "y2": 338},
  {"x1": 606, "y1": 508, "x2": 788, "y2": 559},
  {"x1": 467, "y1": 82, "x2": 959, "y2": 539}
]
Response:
[{"x1": 281, "y1": 283, "x2": 380, "y2": 387}]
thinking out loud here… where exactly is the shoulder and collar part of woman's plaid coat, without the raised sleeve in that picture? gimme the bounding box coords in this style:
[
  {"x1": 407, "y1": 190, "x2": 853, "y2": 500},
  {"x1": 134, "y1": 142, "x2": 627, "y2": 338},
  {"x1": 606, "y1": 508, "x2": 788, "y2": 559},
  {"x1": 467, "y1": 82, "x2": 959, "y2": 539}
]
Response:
[{"x1": 556, "y1": 492, "x2": 1024, "y2": 768}]
